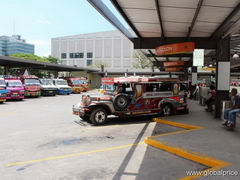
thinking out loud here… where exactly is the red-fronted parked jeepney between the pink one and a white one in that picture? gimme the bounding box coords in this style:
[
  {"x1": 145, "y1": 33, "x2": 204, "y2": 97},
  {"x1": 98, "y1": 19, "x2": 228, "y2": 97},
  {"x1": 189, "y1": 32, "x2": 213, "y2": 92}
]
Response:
[{"x1": 21, "y1": 76, "x2": 41, "y2": 97}]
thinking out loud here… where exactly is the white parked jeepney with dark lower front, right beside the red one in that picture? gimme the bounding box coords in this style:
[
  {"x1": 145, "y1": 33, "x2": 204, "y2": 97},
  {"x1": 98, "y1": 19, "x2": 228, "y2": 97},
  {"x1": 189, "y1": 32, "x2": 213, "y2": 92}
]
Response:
[{"x1": 39, "y1": 79, "x2": 57, "y2": 96}]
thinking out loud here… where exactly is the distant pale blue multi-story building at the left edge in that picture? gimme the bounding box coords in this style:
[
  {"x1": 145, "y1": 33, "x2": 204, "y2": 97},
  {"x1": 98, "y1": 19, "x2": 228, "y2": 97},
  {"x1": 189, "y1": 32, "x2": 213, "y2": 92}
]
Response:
[{"x1": 0, "y1": 35, "x2": 34, "y2": 56}]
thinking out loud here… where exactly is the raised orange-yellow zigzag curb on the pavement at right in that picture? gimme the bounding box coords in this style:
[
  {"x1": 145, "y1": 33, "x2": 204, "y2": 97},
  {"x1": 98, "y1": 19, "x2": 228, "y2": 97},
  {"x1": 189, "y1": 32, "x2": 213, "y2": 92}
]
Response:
[{"x1": 144, "y1": 118, "x2": 231, "y2": 180}]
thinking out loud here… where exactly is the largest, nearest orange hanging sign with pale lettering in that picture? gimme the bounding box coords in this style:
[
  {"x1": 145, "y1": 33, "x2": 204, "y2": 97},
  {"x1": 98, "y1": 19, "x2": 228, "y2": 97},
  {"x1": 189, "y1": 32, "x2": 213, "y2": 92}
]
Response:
[{"x1": 155, "y1": 42, "x2": 195, "y2": 56}]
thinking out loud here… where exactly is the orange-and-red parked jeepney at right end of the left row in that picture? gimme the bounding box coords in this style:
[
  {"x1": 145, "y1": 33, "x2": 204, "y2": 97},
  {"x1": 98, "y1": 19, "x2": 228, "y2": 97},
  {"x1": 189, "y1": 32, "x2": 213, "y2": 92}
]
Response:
[{"x1": 64, "y1": 77, "x2": 88, "y2": 94}]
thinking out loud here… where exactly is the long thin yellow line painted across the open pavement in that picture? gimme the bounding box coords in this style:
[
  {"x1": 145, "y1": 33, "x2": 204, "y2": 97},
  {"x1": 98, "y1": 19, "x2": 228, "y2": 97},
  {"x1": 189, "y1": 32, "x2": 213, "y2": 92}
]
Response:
[{"x1": 6, "y1": 142, "x2": 144, "y2": 167}]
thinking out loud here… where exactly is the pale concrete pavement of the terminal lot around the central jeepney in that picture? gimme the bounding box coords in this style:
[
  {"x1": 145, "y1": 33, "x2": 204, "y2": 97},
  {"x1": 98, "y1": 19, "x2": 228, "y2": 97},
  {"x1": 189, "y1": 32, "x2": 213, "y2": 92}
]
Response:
[{"x1": 0, "y1": 94, "x2": 238, "y2": 180}]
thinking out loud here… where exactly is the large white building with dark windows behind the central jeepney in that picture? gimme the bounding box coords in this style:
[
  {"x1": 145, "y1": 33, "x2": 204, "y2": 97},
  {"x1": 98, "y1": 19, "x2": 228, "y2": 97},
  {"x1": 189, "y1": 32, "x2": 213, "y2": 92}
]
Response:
[{"x1": 51, "y1": 31, "x2": 151, "y2": 72}]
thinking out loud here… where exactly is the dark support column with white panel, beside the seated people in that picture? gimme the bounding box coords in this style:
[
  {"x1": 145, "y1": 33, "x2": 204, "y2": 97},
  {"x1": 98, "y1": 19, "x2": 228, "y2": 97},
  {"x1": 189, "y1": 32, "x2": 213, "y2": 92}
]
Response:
[{"x1": 215, "y1": 36, "x2": 230, "y2": 118}]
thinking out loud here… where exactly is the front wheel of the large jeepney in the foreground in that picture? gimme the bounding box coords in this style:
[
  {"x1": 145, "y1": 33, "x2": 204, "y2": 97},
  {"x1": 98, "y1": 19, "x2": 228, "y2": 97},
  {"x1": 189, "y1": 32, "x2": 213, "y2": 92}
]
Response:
[{"x1": 90, "y1": 108, "x2": 108, "y2": 126}]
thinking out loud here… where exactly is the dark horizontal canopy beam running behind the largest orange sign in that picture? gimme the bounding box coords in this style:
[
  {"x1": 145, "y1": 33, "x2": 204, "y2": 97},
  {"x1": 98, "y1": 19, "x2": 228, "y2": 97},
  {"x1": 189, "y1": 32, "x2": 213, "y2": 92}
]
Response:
[{"x1": 132, "y1": 37, "x2": 217, "y2": 49}]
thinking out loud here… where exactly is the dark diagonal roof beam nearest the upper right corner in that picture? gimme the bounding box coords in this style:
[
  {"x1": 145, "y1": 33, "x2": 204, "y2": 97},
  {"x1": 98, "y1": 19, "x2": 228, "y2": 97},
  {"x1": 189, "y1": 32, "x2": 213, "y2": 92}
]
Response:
[{"x1": 211, "y1": 3, "x2": 240, "y2": 39}]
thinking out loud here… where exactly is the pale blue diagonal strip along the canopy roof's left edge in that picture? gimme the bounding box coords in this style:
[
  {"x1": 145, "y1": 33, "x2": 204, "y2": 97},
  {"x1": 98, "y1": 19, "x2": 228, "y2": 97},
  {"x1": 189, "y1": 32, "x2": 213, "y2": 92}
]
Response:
[{"x1": 87, "y1": 0, "x2": 133, "y2": 40}]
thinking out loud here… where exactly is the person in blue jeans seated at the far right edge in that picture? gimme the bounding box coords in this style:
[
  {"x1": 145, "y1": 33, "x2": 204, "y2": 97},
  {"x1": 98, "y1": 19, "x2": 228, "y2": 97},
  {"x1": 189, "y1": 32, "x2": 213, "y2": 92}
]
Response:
[{"x1": 222, "y1": 88, "x2": 240, "y2": 130}]
